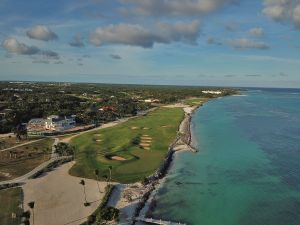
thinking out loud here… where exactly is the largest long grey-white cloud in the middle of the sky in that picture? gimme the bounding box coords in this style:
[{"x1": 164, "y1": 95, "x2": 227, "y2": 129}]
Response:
[{"x1": 90, "y1": 21, "x2": 200, "y2": 48}]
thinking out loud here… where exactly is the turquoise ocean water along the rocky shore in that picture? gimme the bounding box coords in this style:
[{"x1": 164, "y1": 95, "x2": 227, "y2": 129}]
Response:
[{"x1": 153, "y1": 89, "x2": 300, "y2": 225}]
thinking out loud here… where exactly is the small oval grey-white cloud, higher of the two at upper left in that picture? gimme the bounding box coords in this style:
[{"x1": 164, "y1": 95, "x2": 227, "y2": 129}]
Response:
[{"x1": 26, "y1": 25, "x2": 58, "y2": 41}]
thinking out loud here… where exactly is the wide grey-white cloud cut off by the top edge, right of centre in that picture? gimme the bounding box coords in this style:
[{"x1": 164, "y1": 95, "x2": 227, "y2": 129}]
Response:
[{"x1": 120, "y1": 0, "x2": 237, "y2": 16}]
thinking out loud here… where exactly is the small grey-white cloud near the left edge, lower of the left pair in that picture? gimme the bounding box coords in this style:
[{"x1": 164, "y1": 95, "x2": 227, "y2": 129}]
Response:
[{"x1": 2, "y1": 38, "x2": 40, "y2": 55}]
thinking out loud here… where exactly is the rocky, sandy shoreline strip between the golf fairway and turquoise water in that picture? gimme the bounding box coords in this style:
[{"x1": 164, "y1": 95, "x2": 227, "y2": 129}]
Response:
[{"x1": 111, "y1": 105, "x2": 201, "y2": 225}]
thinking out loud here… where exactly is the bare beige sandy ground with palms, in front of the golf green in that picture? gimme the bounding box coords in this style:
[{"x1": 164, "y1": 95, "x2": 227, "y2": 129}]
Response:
[{"x1": 23, "y1": 162, "x2": 106, "y2": 225}]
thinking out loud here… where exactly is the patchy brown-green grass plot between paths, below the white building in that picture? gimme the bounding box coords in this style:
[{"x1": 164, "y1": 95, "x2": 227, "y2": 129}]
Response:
[{"x1": 0, "y1": 138, "x2": 54, "y2": 181}]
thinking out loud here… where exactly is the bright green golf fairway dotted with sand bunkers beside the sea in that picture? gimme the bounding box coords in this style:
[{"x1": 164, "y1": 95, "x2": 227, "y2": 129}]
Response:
[{"x1": 70, "y1": 108, "x2": 184, "y2": 183}]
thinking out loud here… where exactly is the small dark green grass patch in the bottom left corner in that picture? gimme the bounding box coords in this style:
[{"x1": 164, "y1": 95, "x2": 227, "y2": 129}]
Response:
[{"x1": 0, "y1": 188, "x2": 23, "y2": 225}]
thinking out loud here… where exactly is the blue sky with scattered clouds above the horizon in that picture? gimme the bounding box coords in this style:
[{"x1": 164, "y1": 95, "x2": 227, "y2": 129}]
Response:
[{"x1": 0, "y1": 0, "x2": 300, "y2": 87}]
